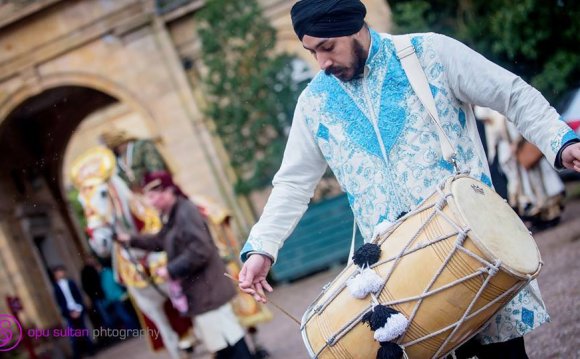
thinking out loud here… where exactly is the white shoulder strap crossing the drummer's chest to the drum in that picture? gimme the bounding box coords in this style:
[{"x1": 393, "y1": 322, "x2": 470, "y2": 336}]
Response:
[{"x1": 392, "y1": 35, "x2": 457, "y2": 167}]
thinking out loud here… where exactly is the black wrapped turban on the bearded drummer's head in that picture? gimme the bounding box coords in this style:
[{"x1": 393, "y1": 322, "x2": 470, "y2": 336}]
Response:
[{"x1": 290, "y1": 0, "x2": 367, "y2": 41}]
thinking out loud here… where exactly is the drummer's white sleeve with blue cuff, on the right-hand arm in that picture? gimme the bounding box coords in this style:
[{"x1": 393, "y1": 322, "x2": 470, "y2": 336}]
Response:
[{"x1": 433, "y1": 35, "x2": 578, "y2": 166}]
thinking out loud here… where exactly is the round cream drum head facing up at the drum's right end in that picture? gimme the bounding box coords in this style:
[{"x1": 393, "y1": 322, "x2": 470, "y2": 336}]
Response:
[{"x1": 451, "y1": 177, "x2": 540, "y2": 277}]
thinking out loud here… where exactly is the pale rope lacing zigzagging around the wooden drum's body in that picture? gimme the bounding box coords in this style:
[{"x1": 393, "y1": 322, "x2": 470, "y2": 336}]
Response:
[{"x1": 302, "y1": 179, "x2": 533, "y2": 357}]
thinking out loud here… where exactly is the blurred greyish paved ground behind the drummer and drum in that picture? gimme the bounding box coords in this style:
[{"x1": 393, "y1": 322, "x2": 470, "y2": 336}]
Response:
[{"x1": 96, "y1": 187, "x2": 580, "y2": 359}]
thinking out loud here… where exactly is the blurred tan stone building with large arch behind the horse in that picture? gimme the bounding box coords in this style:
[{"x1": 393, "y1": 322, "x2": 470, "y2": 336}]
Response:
[{"x1": 0, "y1": 0, "x2": 390, "y2": 344}]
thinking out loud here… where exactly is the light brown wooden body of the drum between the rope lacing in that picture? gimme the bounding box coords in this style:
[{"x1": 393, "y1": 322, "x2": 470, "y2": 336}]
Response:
[{"x1": 302, "y1": 177, "x2": 539, "y2": 358}]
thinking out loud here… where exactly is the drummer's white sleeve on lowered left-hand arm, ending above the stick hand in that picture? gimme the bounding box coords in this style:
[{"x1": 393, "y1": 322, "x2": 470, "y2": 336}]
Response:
[{"x1": 241, "y1": 93, "x2": 327, "y2": 262}]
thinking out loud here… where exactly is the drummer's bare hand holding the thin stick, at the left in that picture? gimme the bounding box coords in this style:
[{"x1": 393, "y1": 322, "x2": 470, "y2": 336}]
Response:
[{"x1": 239, "y1": 254, "x2": 273, "y2": 303}]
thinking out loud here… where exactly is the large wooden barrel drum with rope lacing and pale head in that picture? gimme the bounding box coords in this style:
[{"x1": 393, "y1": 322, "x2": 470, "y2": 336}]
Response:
[{"x1": 301, "y1": 175, "x2": 542, "y2": 358}]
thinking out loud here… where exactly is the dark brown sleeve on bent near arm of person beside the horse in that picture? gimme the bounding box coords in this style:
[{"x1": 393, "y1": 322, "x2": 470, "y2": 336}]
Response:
[{"x1": 167, "y1": 204, "x2": 217, "y2": 279}]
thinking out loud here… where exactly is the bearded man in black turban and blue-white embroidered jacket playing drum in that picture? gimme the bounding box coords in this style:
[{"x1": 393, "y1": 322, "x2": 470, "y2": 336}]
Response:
[{"x1": 240, "y1": 0, "x2": 580, "y2": 358}]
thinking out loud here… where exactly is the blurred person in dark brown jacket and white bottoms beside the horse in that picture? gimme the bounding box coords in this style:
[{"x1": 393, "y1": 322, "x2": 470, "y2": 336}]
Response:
[{"x1": 118, "y1": 172, "x2": 252, "y2": 359}]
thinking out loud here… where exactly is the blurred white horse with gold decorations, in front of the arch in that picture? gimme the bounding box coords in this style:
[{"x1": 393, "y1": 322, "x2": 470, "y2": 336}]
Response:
[{"x1": 77, "y1": 174, "x2": 188, "y2": 359}]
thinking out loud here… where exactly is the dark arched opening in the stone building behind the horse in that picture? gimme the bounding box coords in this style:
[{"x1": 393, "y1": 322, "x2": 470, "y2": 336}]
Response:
[{"x1": 0, "y1": 86, "x2": 128, "y2": 328}]
